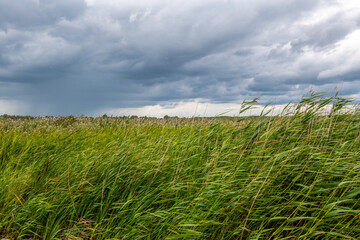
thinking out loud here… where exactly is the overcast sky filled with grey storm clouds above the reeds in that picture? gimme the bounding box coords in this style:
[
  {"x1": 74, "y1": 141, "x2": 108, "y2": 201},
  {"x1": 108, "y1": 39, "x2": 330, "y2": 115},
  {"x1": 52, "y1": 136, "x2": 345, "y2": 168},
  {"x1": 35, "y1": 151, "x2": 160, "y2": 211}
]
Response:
[{"x1": 0, "y1": 0, "x2": 360, "y2": 116}]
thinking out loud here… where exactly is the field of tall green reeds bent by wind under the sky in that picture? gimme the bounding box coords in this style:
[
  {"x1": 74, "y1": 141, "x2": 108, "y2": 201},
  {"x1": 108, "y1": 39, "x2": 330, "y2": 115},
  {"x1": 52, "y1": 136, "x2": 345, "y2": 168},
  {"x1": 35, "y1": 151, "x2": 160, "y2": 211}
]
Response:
[{"x1": 0, "y1": 93, "x2": 360, "y2": 239}]
